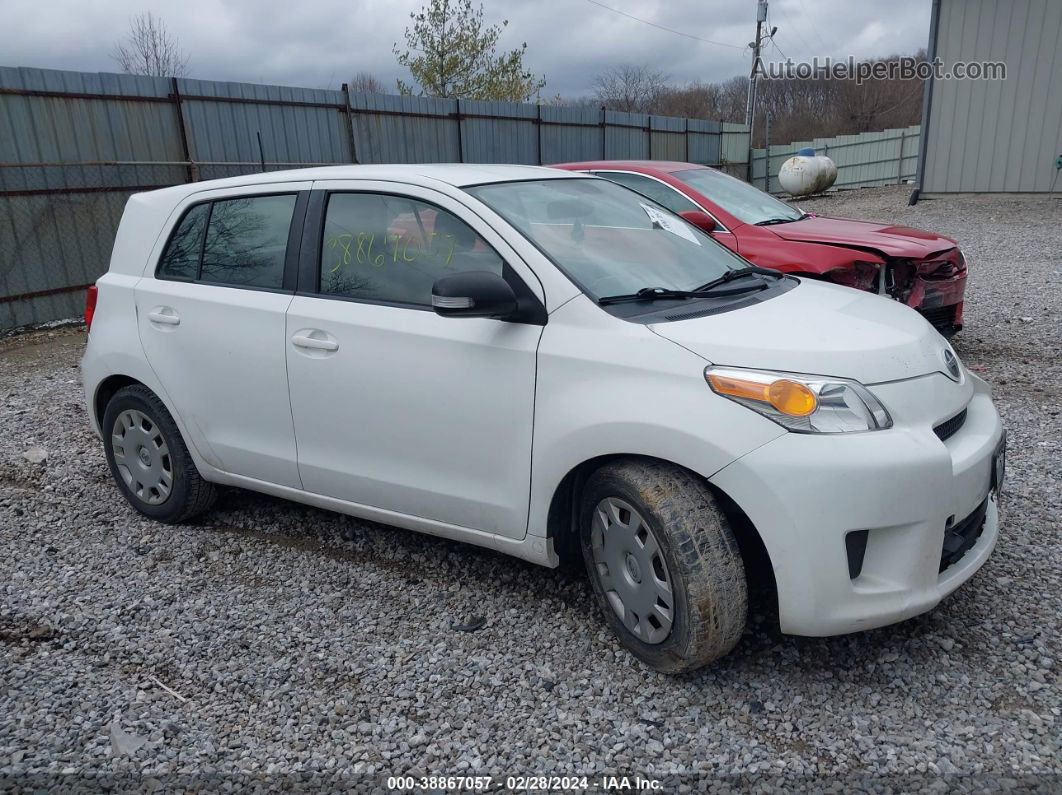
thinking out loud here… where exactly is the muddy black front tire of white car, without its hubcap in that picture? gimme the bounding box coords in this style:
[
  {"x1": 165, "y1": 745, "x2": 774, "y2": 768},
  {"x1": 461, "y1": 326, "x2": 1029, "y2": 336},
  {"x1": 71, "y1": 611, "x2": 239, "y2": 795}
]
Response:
[{"x1": 579, "y1": 459, "x2": 749, "y2": 674}]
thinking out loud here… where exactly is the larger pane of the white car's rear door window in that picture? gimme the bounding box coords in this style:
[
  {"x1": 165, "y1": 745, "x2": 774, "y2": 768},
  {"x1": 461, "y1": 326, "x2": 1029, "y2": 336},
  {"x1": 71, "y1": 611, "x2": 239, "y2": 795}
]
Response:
[{"x1": 200, "y1": 194, "x2": 295, "y2": 289}]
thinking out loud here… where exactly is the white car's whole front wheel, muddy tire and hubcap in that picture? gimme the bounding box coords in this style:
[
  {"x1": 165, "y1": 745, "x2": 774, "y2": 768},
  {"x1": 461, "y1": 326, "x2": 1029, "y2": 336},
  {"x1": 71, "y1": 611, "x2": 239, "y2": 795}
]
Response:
[{"x1": 580, "y1": 459, "x2": 748, "y2": 673}]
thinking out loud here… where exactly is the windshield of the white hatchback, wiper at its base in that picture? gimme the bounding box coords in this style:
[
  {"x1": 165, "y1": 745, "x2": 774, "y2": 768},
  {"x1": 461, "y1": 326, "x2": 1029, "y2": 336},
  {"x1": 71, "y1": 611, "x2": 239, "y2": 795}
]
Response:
[{"x1": 466, "y1": 178, "x2": 748, "y2": 298}]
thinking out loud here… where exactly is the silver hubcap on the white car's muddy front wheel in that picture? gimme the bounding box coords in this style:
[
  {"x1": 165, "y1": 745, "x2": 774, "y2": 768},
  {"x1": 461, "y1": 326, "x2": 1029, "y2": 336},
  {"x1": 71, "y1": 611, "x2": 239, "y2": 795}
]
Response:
[{"x1": 590, "y1": 497, "x2": 674, "y2": 643}]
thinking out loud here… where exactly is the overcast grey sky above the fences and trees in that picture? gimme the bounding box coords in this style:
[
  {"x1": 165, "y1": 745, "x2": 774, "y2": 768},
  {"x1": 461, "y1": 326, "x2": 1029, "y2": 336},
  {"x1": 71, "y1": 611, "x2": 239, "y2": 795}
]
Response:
[{"x1": 0, "y1": 0, "x2": 930, "y2": 97}]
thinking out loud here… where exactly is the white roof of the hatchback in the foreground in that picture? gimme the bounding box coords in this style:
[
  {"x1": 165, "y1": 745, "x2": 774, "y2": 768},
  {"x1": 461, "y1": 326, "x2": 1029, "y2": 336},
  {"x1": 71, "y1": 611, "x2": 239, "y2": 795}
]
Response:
[{"x1": 139, "y1": 162, "x2": 576, "y2": 203}]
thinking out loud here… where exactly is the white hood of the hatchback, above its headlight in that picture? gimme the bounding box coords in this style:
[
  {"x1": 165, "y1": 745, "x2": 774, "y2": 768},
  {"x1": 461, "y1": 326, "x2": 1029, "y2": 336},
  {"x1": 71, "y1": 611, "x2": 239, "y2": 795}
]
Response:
[{"x1": 650, "y1": 279, "x2": 948, "y2": 384}]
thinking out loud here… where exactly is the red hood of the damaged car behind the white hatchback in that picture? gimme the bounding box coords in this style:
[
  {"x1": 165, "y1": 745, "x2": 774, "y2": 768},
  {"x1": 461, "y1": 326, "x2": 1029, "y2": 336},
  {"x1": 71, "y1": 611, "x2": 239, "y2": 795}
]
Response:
[{"x1": 767, "y1": 217, "x2": 955, "y2": 259}]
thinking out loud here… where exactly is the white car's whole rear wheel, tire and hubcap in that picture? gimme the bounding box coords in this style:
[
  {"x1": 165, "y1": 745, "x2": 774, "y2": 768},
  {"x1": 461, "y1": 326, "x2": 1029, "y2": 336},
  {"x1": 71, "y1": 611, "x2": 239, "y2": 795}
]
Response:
[{"x1": 101, "y1": 384, "x2": 217, "y2": 523}]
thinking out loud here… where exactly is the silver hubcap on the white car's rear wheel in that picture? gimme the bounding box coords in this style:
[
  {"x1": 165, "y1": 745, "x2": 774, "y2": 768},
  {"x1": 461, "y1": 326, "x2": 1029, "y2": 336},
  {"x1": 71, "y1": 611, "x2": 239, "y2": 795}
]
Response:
[{"x1": 110, "y1": 409, "x2": 173, "y2": 505}]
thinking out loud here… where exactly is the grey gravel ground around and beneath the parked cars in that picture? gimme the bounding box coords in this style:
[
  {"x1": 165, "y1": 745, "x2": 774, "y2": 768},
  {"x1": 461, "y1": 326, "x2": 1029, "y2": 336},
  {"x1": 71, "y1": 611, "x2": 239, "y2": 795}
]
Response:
[{"x1": 0, "y1": 188, "x2": 1062, "y2": 791}]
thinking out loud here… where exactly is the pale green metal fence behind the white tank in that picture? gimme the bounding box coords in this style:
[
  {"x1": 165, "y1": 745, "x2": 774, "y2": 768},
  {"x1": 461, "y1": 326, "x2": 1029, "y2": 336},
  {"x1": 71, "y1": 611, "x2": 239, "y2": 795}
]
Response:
[{"x1": 752, "y1": 124, "x2": 920, "y2": 193}]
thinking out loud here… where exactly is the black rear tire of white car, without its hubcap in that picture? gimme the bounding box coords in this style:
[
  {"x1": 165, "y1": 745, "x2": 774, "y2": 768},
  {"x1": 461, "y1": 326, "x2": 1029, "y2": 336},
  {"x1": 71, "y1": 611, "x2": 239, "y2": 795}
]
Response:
[{"x1": 101, "y1": 384, "x2": 218, "y2": 524}]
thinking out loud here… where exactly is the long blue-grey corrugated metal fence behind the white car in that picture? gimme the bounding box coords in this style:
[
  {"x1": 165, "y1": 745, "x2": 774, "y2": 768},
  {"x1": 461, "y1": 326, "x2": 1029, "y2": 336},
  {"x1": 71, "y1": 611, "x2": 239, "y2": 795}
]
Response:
[{"x1": 0, "y1": 67, "x2": 749, "y2": 329}]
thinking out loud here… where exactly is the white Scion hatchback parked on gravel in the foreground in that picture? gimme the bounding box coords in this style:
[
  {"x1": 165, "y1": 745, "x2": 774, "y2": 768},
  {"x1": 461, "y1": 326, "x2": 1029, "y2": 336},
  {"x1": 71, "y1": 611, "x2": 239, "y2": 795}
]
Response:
[{"x1": 82, "y1": 165, "x2": 1005, "y2": 672}]
